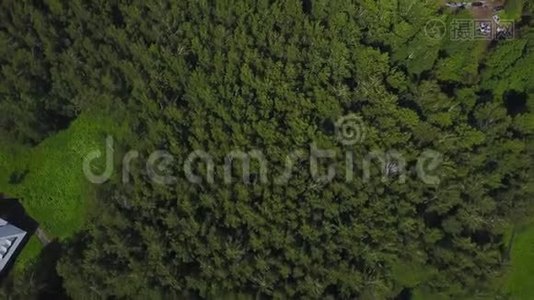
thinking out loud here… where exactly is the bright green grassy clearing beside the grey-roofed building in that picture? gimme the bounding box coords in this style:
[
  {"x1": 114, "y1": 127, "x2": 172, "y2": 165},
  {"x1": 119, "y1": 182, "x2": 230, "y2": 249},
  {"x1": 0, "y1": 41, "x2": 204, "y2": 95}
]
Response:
[{"x1": 0, "y1": 114, "x2": 126, "y2": 268}]
